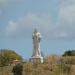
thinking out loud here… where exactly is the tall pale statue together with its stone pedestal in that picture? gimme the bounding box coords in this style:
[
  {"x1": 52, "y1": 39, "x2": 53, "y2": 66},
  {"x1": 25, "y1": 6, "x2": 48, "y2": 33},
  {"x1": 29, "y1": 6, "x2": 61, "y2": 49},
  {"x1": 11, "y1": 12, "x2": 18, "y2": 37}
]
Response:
[{"x1": 30, "y1": 29, "x2": 43, "y2": 63}]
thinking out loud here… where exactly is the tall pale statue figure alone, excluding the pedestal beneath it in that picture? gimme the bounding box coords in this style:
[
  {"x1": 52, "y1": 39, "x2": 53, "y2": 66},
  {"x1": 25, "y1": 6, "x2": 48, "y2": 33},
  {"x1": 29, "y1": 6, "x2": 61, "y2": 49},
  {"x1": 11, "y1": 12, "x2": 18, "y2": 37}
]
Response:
[{"x1": 32, "y1": 29, "x2": 41, "y2": 56}]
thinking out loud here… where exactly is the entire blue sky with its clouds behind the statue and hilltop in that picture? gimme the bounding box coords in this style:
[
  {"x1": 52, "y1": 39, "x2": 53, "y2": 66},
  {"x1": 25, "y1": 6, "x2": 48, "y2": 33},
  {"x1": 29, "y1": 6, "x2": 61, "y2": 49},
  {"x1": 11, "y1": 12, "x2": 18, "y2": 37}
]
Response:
[{"x1": 0, "y1": 0, "x2": 75, "y2": 59}]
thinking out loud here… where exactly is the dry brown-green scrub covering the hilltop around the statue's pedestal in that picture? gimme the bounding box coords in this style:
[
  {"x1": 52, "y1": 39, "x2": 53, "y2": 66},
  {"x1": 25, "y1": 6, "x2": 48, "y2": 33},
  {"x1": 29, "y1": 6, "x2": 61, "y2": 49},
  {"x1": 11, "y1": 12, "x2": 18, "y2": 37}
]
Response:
[{"x1": 0, "y1": 50, "x2": 75, "y2": 75}]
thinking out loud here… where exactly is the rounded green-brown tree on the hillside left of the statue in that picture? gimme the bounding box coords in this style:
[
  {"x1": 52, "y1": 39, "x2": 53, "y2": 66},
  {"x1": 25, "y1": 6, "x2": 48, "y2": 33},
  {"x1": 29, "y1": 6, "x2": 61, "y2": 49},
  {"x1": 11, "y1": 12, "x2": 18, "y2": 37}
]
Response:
[{"x1": 0, "y1": 49, "x2": 22, "y2": 66}]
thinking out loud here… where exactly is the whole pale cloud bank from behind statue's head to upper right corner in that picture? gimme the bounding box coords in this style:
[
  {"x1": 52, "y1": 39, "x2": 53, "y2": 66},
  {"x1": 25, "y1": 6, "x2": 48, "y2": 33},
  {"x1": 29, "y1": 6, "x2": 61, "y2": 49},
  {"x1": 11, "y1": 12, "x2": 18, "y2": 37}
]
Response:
[{"x1": 5, "y1": 0, "x2": 75, "y2": 39}]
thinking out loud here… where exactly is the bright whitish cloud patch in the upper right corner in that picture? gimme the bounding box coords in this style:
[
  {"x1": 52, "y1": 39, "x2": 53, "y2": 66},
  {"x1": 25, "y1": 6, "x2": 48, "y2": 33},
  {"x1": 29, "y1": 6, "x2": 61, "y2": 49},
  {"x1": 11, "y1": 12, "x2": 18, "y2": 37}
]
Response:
[{"x1": 59, "y1": 0, "x2": 75, "y2": 23}]
